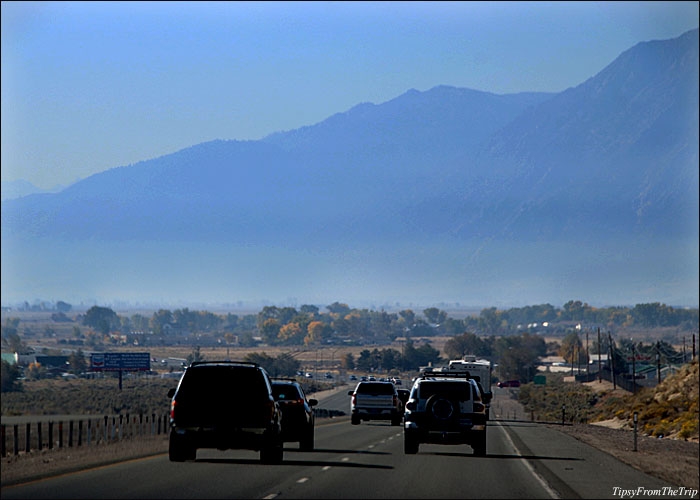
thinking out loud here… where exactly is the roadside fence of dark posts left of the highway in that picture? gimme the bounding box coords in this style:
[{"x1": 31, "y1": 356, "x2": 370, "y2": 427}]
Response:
[{"x1": 0, "y1": 413, "x2": 169, "y2": 457}]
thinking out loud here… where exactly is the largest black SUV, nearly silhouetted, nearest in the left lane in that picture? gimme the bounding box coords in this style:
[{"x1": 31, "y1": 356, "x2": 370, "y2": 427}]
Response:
[{"x1": 168, "y1": 361, "x2": 283, "y2": 463}]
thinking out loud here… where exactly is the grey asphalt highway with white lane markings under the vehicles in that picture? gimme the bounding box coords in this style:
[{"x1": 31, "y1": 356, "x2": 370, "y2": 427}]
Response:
[{"x1": 2, "y1": 390, "x2": 672, "y2": 499}]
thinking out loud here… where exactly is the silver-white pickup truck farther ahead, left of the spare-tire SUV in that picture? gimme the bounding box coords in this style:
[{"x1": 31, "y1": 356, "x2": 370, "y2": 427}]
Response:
[{"x1": 348, "y1": 382, "x2": 403, "y2": 425}]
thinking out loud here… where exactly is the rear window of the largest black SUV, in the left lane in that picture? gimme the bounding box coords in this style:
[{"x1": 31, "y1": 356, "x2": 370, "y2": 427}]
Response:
[{"x1": 177, "y1": 365, "x2": 269, "y2": 401}]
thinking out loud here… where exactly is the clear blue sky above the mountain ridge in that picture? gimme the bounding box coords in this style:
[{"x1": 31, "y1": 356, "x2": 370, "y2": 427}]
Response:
[{"x1": 1, "y1": 2, "x2": 698, "y2": 189}]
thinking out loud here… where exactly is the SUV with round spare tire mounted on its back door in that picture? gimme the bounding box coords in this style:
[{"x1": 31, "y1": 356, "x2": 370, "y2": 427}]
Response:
[{"x1": 404, "y1": 371, "x2": 487, "y2": 455}]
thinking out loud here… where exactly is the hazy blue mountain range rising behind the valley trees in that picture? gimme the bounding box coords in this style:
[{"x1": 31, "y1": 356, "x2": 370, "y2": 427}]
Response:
[{"x1": 2, "y1": 29, "x2": 699, "y2": 305}]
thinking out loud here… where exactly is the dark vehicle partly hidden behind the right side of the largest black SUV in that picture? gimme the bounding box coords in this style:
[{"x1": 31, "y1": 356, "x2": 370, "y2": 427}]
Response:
[{"x1": 272, "y1": 378, "x2": 318, "y2": 451}]
